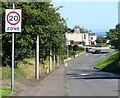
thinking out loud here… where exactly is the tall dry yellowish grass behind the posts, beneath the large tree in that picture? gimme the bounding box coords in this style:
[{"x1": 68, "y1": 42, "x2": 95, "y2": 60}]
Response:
[{"x1": 0, "y1": 57, "x2": 60, "y2": 79}]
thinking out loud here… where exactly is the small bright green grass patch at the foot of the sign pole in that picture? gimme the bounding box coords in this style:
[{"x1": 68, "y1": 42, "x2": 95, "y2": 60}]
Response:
[{"x1": 0, "y1": 86, "x2": 19, "y2": 98}]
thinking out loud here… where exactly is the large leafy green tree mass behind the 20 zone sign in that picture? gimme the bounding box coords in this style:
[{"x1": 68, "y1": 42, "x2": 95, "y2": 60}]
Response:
[{"x1": 0, "y1": 2, "x2": 68, "y2": 65}]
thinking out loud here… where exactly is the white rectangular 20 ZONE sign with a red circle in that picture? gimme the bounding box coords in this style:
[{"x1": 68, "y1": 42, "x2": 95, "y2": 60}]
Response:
[{"x1": 5, "y1": 9, "x2": 21, "y2": 32}]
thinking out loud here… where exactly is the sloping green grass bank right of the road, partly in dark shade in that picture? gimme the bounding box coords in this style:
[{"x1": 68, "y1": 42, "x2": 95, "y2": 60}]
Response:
[{"x1": 94, "y1": 51, "x2": 120, "y2": 73}]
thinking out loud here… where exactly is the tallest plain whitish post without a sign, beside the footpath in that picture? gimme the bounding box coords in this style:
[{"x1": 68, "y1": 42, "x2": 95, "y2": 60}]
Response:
[{"x1": 36, "y1": 35, "x2": 39, "y2": 79}]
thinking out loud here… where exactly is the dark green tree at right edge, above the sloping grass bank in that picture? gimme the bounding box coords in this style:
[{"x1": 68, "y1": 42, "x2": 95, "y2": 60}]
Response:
[{"x1": 106, "y1": 24, "x2": 120, "y2": 51}]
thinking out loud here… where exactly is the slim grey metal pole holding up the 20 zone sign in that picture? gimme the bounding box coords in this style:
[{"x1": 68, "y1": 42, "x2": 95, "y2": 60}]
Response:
[{"x1": 11, "y1": 3, "x2": 15, "y2": 91}]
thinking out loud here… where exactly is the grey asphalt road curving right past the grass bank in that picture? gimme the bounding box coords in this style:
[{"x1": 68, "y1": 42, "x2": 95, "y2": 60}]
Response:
[{"x1": 65, "y1": 49, "x2": 120, "y2": 96}]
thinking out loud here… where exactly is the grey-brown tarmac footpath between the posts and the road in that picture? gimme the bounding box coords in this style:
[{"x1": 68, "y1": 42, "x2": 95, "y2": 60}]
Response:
[{"x1": 20, "y1": 64, "x2": 66, "y2": 96}]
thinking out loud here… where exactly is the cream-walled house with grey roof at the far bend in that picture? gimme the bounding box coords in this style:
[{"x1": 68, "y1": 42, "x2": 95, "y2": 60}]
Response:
[{"x1": 65, "y1": 26, "x2": 97, "y2": 46}]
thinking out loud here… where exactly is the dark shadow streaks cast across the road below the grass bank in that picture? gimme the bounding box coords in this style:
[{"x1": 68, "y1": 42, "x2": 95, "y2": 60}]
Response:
[{"x1": 66, "y1": 69, "x2": 120, "y2": 79}]
